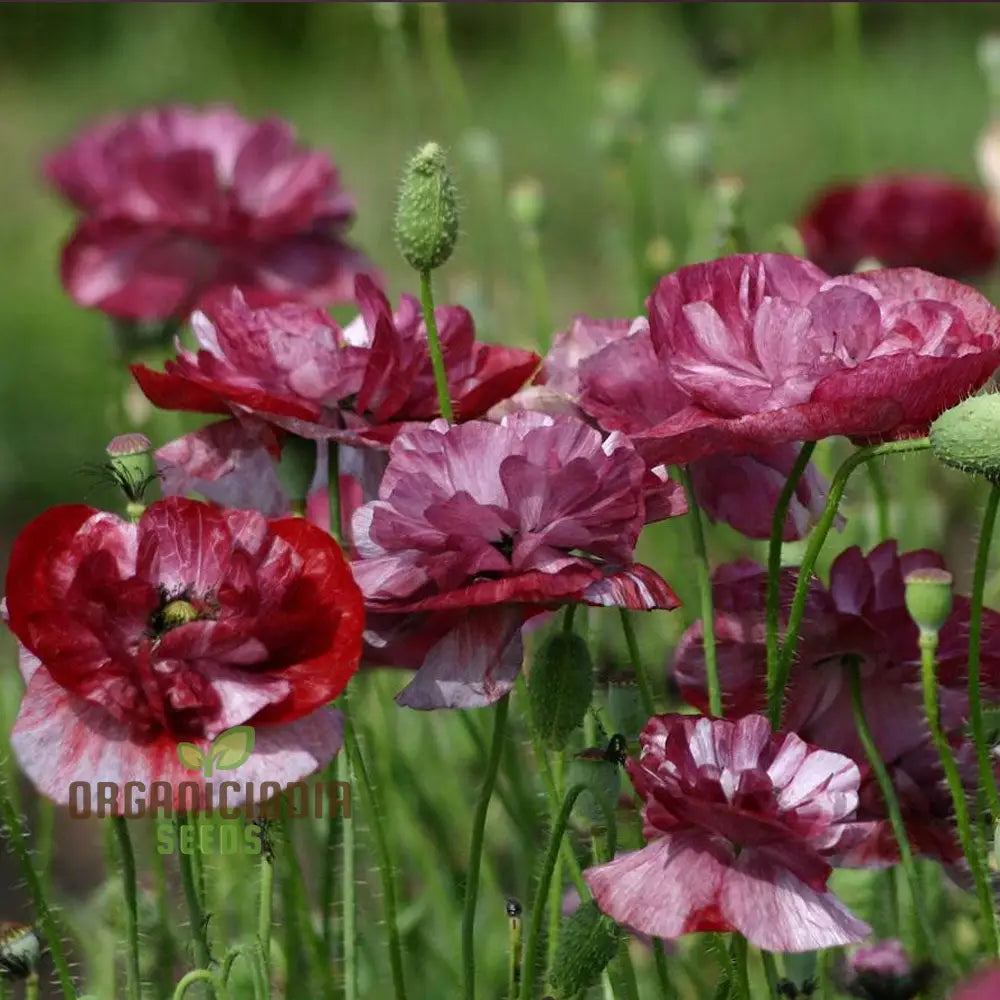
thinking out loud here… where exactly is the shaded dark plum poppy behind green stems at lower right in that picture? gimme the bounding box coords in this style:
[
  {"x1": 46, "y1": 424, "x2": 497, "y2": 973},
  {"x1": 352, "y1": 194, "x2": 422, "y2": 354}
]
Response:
[{"x1": 673, "y1": 541, "x2": 1000, "y2": 866}]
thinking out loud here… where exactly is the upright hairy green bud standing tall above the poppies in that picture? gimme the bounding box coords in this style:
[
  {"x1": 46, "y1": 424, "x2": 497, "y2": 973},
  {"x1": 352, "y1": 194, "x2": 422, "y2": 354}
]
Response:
[{"x1": 396, "y1": 142, "x2": 458, "y2": 272}]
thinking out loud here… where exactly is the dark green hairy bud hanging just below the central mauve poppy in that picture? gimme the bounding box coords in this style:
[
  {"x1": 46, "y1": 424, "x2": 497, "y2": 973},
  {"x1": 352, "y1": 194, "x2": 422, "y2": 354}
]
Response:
[{"x1": 528, "y1": 631, "x2": 594, "y2": 750}]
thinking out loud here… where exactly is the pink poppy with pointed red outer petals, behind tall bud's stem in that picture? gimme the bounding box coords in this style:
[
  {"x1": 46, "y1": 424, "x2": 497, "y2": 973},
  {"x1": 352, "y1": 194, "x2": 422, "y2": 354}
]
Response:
[{"x1": 132, "y1": 277, "x2": 539, "y2": 446}]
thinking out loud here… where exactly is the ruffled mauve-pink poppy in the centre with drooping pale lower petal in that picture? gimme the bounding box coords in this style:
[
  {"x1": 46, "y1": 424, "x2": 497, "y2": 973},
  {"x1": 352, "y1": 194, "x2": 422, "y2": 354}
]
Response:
[{"x1": 352, "y1": 412, "x2": 679, "y2": 708}]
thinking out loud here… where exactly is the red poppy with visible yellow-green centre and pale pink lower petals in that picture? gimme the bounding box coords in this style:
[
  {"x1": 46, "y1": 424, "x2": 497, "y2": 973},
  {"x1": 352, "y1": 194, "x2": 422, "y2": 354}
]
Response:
[{"x1": 6, "y1": 497, "x2": 363, "y2": 808}]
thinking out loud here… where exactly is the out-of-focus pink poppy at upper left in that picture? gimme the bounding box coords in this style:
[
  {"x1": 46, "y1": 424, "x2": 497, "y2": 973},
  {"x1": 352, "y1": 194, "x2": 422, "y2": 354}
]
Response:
[{"x1": 45, "y1": 106, "x2": 376, "y2": 320}]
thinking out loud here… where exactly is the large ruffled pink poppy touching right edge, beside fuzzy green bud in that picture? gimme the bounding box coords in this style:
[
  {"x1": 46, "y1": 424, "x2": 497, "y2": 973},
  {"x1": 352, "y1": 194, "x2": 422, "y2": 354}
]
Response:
[{"x1": 628, "y1": 254, "x2": 1000, "y2": 464}]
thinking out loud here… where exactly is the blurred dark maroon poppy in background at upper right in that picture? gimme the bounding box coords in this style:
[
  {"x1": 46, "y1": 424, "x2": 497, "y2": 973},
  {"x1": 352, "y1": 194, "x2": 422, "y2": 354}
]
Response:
[{"x1": 799, "y1": 175, "x2": 1000, "y2": 278}]
